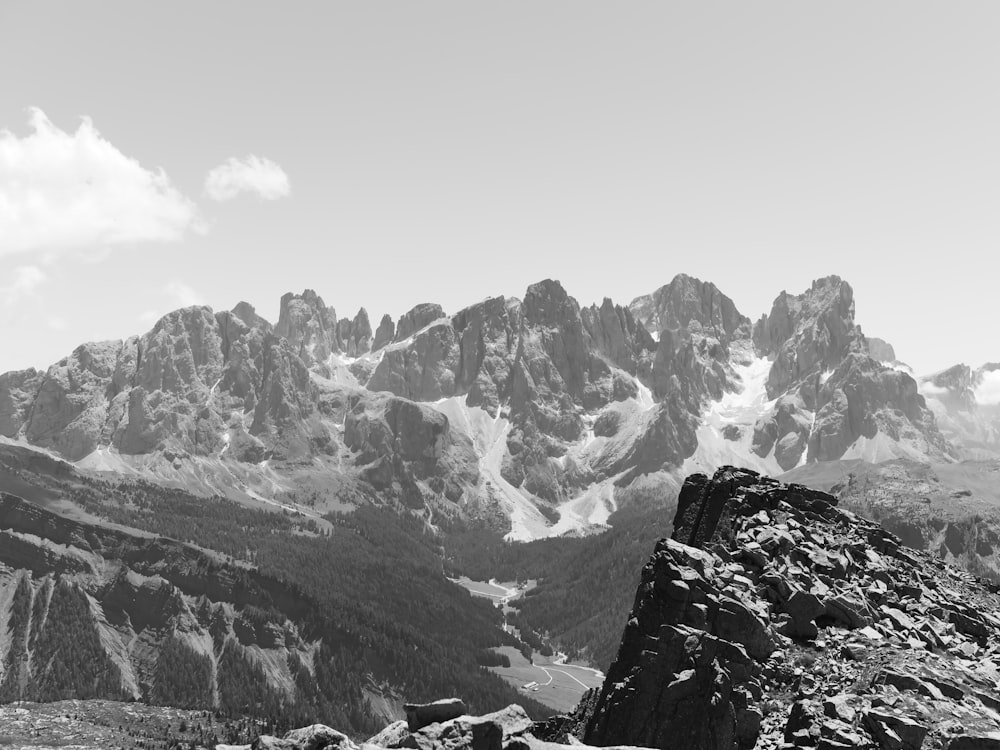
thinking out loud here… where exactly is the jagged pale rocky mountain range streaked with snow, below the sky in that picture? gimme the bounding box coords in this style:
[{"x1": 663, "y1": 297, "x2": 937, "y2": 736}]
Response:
[{"x1": 0, "y1": 274, "x2": 968, "y2": 540}]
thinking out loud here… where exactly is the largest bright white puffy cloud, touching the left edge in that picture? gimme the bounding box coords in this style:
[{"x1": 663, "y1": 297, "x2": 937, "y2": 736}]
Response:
[{"x1": 0, "y1": 108, "x2": 203, "y2": 254}]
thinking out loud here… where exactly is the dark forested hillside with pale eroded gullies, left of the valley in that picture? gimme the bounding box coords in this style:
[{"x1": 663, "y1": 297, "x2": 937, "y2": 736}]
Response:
[{"x1": 0, "y1": 451, "x2": 546, "y2": 731}]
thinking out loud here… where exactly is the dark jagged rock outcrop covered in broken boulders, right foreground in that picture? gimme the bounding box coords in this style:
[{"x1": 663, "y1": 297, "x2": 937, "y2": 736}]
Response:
[{"x1": 547, "y1": 467, "x2": 1000, "y2": 750}]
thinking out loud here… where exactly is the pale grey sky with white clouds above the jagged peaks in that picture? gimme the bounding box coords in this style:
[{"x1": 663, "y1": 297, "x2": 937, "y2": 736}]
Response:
[{"x1": 0, "y1": 0, "x2": 1000, "y2": 373}]
